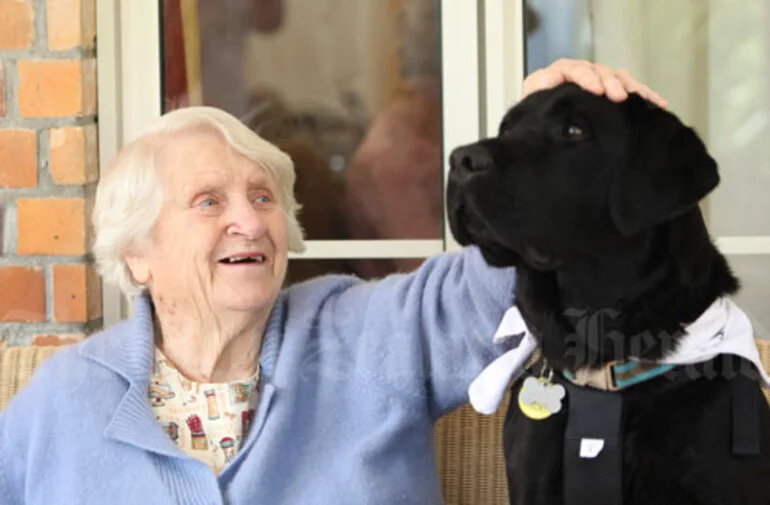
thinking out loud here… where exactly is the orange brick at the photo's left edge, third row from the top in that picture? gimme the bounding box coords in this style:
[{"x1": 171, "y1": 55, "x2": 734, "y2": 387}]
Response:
[{"x1": 0, "y1": 129, "x2": 37, "y2": 188}]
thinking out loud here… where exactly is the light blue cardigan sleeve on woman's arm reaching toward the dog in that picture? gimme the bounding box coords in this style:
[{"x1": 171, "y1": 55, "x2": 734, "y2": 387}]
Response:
[{"x1": 324, "y1": 247, "x2": 515, "y2": 419}]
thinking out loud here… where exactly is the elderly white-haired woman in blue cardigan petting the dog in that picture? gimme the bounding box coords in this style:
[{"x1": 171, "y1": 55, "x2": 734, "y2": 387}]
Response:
[{"x1": 0, "y1": 61, "x2": 655, "y2": 505}]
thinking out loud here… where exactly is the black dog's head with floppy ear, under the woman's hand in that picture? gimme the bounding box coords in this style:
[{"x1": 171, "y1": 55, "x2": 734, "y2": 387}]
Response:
[{"x1": 447, "y1": 84, "x2": 719, "y2": 271}]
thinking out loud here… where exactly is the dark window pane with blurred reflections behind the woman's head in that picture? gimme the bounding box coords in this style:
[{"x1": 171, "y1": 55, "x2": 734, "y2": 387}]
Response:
[{"x1": 163, "y1": 0, "x2": 443, "y2": 288}]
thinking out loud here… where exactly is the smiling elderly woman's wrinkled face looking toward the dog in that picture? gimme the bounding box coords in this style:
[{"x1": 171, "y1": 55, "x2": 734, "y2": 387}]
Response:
[{"x1": 127, "y1": 131, "x2": 288, "y2": 316}]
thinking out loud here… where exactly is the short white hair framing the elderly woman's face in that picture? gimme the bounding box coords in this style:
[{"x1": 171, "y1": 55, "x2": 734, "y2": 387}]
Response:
[{"x1": 92, "y1": 107, "x2": 305, "y2": 296}]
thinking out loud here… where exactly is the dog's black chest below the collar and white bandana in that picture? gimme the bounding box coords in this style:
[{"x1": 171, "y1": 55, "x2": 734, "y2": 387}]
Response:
[{"x1": 504, "y1": 366, "x2": 770, "y2": 505}]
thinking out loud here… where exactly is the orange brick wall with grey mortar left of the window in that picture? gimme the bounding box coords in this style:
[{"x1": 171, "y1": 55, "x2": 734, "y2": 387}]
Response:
[{"x1": 0, "y1": 0, "x2": 101, "y2": 346}]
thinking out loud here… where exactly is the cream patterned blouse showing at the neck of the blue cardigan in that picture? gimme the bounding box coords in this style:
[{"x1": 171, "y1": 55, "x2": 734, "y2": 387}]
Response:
[{"x1": 148, "y1": 348, "x2": 259, "y2": 474}]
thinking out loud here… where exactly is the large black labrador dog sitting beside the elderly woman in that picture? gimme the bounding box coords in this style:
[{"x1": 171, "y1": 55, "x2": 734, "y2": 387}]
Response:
[{"x1": 447, "y1": 84, "x2": 770, "y2": 505}]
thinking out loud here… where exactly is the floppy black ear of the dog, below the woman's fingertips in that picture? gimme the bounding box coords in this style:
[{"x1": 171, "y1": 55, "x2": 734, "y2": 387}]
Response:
[{"x1": 609, "y1": 94, "x2": 719, "y2": 237}]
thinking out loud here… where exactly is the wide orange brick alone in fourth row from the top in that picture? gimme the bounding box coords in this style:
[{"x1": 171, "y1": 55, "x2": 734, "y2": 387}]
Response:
[{"x1": 16, "y1": 198, "x2": 87, "y2": 256}]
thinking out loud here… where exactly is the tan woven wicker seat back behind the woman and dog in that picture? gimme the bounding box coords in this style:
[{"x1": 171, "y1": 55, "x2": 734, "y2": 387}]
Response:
[{"x1": 0, "y1": 341, "x2": 770, "y2": 505}]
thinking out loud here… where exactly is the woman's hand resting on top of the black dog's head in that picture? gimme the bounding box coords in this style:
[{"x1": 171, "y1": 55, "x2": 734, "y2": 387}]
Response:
[{"x1": 522, "y1": 58, "x2": 668, "y2": 107}]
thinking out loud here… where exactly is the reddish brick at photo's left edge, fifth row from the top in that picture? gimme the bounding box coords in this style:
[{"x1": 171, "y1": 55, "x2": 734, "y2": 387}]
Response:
[{"x1": 0, "y1": 266, "x2": 45, "y2": 322}]
